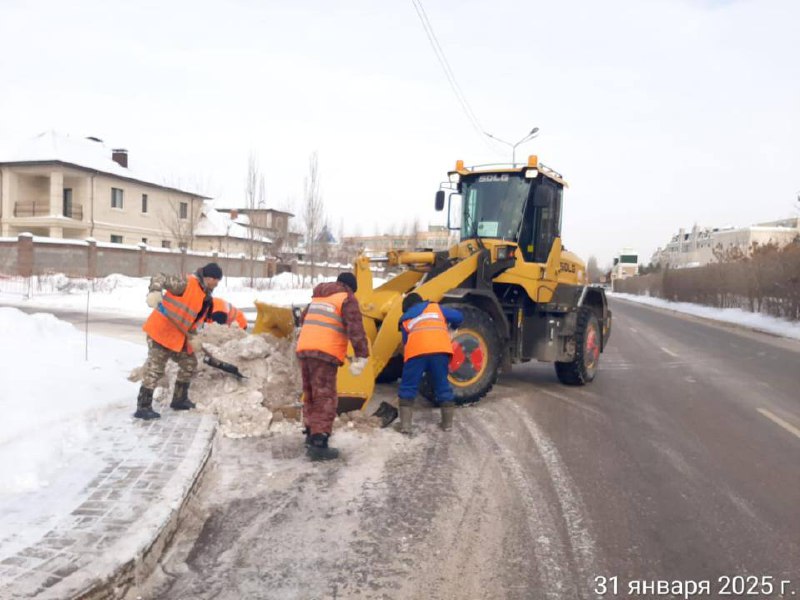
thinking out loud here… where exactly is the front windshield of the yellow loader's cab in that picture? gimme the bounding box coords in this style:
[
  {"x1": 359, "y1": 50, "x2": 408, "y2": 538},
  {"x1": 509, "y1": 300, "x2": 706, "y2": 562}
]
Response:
[{"x1": 461, "y1": 173, "x2": 531, "y2": 242}]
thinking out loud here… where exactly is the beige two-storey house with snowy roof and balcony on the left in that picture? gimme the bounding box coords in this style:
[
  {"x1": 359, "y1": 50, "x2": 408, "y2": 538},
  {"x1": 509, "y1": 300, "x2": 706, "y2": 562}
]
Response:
[{"x1": 0, "y1": 132, "x2": 208, "y2": 249}]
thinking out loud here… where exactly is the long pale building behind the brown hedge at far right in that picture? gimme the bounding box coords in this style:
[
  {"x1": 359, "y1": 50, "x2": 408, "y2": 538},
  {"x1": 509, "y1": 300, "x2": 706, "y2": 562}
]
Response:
[{"x1": 651, "y1": 217, "x2": 800, "y2": 269}]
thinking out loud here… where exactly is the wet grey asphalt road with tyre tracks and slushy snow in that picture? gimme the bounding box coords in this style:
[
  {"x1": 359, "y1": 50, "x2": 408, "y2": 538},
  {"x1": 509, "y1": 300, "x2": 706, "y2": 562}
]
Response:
[{"x1": 133, "y1": 301, "x2": 800, "y2": 599}]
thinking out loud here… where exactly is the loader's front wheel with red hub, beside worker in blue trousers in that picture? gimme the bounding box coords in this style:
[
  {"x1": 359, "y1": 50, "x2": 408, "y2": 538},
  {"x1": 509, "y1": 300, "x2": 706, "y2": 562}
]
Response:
[{"x1": 420, "y1": 304, "x2": 503, "y2": 405}]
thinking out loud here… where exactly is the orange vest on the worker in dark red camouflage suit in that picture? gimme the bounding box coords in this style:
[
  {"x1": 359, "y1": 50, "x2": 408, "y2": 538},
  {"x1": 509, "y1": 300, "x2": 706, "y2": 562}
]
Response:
[{"x1": 297, "y1": 292, "x2": 348, "y2": 362}]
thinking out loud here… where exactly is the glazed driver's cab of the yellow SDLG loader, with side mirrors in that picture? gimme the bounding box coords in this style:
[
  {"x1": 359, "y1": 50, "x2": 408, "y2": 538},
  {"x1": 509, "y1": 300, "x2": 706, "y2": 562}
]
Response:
[{"x1": 436, "y1": 161, "x2": 564, "y2": 263}]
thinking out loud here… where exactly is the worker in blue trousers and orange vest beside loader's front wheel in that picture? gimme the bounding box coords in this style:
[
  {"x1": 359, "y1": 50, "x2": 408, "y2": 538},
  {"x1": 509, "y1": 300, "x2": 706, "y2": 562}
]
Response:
[{"x1": 397, "y1": 292, "x2": 464, "y2": 434}]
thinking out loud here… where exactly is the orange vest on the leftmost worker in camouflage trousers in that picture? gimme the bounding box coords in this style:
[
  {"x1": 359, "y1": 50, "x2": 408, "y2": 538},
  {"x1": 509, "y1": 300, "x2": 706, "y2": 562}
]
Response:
[{"x1": 142, "y1": 275, "x2": 206, "y2": 354}]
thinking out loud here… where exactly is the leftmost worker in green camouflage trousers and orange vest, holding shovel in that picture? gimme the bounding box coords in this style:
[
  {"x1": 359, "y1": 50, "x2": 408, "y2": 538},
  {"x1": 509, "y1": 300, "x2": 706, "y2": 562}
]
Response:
[{"x1": 133, "y1": 263, "x2": 222, "y2": 421}]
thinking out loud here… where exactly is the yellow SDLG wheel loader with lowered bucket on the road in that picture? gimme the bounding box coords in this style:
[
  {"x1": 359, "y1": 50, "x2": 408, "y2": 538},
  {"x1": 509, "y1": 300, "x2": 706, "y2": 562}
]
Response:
[{"x1": 254, "y1": 156, "x2": 611, "y2": 412}]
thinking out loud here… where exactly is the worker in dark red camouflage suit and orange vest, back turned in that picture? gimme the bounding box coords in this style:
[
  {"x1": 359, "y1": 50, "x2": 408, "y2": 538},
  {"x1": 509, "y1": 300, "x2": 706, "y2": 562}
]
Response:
[{"x1": 297, "y1": 273, "x2": 369, "y2": 460}]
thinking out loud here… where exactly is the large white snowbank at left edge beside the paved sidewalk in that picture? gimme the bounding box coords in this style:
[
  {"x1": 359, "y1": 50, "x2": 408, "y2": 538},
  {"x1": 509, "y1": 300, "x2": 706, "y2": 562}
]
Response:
[{"x1": 0, "y1": 307, "x2": 145, "y2": 496}]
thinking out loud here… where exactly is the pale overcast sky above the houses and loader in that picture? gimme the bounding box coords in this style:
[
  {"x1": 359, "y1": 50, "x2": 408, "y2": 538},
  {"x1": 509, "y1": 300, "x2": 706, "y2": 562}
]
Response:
[{"x1": 0, "y1": 0, "x2": 800, "y2": 265}]
